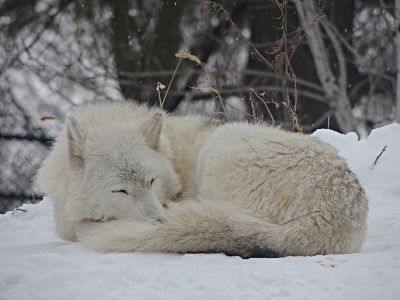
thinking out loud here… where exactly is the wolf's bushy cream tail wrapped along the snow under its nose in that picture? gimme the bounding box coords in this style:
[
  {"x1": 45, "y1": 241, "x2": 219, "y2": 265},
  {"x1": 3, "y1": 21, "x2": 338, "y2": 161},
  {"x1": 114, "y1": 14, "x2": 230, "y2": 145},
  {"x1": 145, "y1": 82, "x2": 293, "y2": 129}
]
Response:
[{"x1": 78, "y1": 200, "x2": 358, "y2": 257}]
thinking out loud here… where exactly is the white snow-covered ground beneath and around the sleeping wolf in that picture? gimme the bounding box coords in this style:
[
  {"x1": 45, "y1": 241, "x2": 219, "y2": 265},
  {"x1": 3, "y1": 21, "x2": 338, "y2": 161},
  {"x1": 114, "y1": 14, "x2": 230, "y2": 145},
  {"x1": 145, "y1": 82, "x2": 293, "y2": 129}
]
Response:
[{"x1": 0, "y1": 124, "x2": 400, "y2": 300}]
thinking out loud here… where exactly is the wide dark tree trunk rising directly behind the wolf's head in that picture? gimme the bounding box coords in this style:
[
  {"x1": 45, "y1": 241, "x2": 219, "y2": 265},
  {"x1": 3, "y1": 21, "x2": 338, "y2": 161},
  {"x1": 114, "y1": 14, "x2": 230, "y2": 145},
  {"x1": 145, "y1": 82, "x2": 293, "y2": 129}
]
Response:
[{"x1": 110, "y1": 0, "x2": 189, "y2": 110}]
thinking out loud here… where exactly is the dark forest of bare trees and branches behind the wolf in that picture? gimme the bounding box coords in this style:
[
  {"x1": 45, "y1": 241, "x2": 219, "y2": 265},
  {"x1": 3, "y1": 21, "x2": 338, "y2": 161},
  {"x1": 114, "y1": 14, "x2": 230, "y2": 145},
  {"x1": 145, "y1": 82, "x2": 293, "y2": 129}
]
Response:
[{"x1": 0, "y1": 0, "x2": 399, "y2": 212}]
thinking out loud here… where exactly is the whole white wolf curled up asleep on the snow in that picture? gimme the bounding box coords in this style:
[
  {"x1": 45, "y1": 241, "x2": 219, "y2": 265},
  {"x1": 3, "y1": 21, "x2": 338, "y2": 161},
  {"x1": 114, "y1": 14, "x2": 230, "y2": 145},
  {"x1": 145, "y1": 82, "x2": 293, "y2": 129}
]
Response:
[{"x1": 38, "y1": 103, "x2": 368, "y2": 257}]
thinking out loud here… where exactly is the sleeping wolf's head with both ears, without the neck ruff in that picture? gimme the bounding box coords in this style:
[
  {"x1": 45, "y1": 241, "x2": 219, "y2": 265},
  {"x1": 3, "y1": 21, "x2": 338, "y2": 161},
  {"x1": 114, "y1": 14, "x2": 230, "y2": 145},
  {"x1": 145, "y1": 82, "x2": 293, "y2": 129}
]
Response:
[{"x1": 66, "y1": 112, "x2": 181, "y2": 221}]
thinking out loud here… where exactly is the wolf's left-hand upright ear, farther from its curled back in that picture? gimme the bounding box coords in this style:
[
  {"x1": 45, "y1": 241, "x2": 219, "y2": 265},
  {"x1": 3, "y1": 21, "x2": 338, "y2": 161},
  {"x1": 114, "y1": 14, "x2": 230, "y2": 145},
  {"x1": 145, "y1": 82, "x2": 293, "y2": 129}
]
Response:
[{"x1": 67, "y1": 118, "x2": 85, "y2": 170}]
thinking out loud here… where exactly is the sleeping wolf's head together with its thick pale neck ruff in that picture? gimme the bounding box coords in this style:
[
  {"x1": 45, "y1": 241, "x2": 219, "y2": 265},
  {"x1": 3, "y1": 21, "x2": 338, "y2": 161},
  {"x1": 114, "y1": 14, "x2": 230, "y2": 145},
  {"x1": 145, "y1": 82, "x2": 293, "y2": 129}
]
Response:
[{"x1": 38, "y1": 103, "x2": 186, "y2": 240}]
